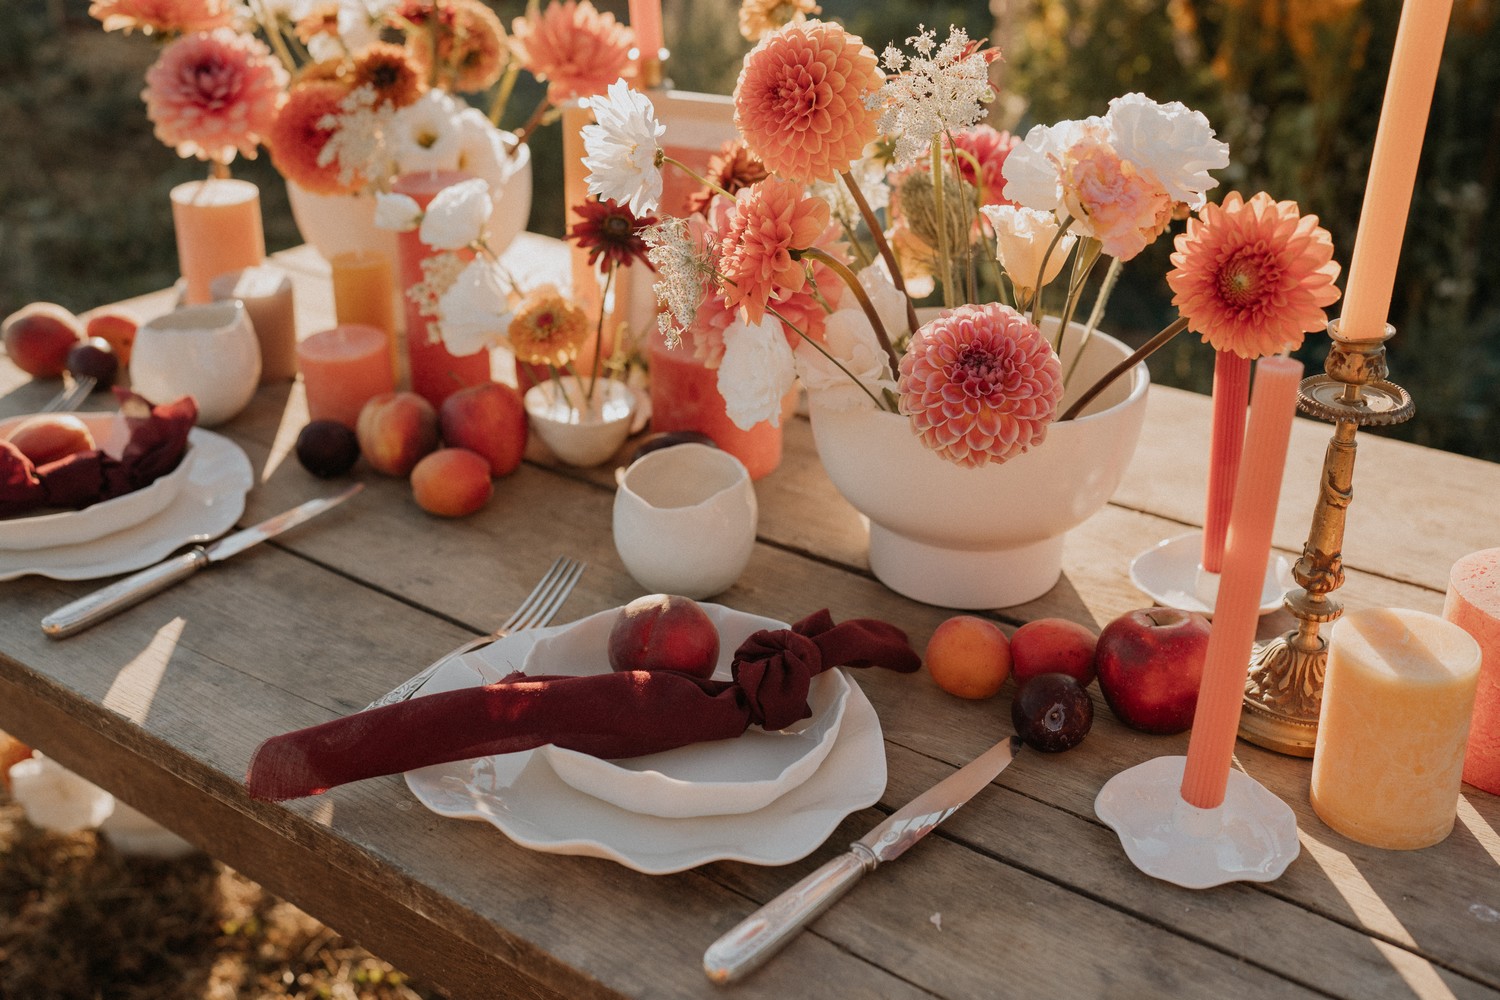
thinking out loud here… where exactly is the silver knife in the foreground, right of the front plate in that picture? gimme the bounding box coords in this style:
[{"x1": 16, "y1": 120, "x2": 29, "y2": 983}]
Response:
[{"x1": 704, "y1": 736, "x2": 1022, "y2": 984}]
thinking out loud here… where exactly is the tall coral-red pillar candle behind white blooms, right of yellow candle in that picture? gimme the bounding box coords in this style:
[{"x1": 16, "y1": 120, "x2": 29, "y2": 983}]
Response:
[{"x1": 393, "y1": 171, "x2": 489, "y2": 406}]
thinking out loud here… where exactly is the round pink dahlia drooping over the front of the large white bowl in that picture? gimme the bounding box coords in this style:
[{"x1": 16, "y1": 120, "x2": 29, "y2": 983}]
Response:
[{"x1": 897, "y1": 303, "x2": 1062, "y2": 468}]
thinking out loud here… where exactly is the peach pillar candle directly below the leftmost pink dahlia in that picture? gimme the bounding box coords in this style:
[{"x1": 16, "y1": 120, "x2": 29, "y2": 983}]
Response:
[{"x1": 171, "y1": 177, "x2": 266, "y2": 306}]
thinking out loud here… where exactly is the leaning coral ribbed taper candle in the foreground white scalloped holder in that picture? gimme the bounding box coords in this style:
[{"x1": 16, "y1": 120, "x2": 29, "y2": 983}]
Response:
[{"x1": 1182, "y1": 357, "x2": 1302, "y2": 810}]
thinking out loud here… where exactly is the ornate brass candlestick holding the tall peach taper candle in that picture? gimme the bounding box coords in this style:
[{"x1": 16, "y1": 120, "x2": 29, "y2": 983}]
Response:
[{"x1": 1239, "y1": 319, "x2": 1415, "y2": 757}]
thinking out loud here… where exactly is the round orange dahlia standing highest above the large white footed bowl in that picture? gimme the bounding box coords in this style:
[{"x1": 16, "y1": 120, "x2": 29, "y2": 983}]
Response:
[{"x1": 735, "y1": 21, "x2": 882, "y2": 183}]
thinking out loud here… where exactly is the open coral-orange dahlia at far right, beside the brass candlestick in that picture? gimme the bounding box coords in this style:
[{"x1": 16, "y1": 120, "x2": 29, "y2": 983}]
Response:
[{"x1": 1167, "y1": 190, "x2": 1338, "y2": 358}]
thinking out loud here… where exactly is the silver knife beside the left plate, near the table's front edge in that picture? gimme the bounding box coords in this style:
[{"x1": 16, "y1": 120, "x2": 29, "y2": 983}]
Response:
[{"x1": 42, "y1": 483, "x2": 365, "y2": 639}]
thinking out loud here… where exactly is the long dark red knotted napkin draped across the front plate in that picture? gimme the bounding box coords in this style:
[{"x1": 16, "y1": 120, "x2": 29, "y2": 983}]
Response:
[{"x1": 245, "y1": 610, "x2": 921, "y2": 801}]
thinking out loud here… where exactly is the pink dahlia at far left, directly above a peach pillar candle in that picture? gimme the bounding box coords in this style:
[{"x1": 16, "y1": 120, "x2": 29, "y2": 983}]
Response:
[{"x1": 141, "y1": 28, "x2": 287, "y2": 163}]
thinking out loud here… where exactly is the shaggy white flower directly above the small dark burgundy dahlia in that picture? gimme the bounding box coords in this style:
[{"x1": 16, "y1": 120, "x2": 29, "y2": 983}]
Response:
[{"x1": 584, "y1": 79, "x2": 666, "y2": 216}]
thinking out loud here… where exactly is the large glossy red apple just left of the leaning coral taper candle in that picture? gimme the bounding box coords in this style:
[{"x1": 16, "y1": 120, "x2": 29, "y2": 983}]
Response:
[{"x1": 1094, "y1": 607, "x2": 1209, "y2": 736}]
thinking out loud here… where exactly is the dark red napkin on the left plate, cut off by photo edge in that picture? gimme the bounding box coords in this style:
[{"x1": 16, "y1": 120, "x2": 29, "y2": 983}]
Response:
[{"x1": 0, "y1": 388, "x2": 198, "y2": 517}]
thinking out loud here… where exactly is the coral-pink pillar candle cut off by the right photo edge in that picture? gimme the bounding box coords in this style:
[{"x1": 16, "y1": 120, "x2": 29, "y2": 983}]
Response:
[{"x1": 1443, "y1": 549, "x2": 1500, "y2": 795}]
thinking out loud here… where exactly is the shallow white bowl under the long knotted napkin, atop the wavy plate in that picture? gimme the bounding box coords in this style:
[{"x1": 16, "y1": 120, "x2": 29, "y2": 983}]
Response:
[{"x1": 525, "y1": 604, "x2": 849, "y2": 819}]
